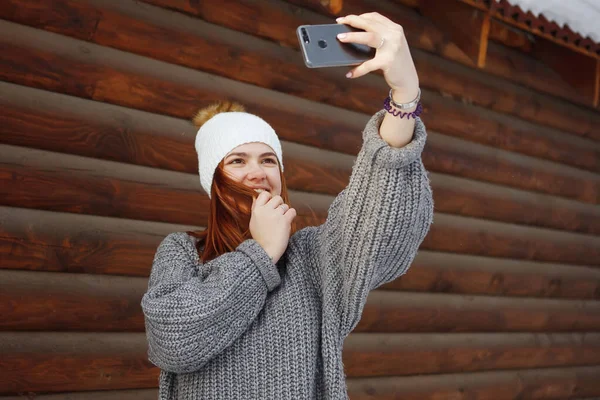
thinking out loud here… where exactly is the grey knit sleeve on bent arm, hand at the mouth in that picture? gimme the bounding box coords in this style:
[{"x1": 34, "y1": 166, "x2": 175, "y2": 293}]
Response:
[{"x1": 142, "y1": 233, "x2": 281, "y2": 373}]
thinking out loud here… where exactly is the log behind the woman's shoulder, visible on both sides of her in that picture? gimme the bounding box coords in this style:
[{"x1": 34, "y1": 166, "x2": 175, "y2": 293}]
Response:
[{"x1": 0, "y1": 207, "x2": 600, "y2": 299}]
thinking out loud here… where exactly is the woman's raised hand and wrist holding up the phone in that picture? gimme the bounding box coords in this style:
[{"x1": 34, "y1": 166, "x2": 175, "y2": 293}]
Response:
[{"x1": 336, "y1": 13, "x2": 419, "y2": 102}]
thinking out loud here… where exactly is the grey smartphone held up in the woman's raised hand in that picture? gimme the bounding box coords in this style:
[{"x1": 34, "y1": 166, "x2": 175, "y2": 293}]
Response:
[{"x1": 296, "y1": 24, "x2": 375, "y2": 68}]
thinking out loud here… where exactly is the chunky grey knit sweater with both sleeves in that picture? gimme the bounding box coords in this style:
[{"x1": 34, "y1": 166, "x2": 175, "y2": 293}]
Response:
[{"x1": 142, "y1": 111, "x2": 433, "y2": 400}]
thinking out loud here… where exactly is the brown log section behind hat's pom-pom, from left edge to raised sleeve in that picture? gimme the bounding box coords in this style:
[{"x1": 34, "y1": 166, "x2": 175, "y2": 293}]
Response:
[{"x1": 0, "y1": 21, "x2": 360, "y2": 154}]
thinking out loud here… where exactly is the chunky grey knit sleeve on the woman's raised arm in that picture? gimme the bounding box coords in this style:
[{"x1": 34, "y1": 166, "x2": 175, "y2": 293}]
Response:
[{"x1": 313, "y1": 111, "x2": 433, "y2": 337}]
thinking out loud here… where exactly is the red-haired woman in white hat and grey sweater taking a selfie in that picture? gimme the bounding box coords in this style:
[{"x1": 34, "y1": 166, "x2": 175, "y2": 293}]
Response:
[{"x1": 142, "y1": 13, "x2": 433, "y2": 400}]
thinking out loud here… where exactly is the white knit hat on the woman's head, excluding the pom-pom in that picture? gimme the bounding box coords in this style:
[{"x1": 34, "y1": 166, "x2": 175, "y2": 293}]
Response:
[{"x1": 196, "y1": 112, "x2": 283, "y2": 198}]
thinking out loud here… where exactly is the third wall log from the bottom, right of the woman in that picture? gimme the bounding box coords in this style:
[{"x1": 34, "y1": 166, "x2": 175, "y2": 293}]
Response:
[{"x1": 355, "y1": 291, "x2": 600, "y2": 333}]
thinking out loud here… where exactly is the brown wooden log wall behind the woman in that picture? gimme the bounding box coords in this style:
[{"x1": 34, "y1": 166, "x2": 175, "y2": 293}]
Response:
[{"x1": 0, "y1": 0, "x2": 600, "y2": 400}]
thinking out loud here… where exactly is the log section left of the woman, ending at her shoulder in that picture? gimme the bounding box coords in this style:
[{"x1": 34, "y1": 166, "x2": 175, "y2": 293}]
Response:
[{"x1": 0, "y1": 207, "x2": 176, "y2": 277}]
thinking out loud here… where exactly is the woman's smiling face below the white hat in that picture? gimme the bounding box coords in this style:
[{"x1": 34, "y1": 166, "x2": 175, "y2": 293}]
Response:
[{"x1": 223, "y1": 142, "x2": 281, "y2": 196}]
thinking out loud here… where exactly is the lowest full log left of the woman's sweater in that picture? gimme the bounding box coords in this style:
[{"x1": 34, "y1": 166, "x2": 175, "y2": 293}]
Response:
[{"x1": 0, "y1": 332, "x2": 159, "y2": 395}]
